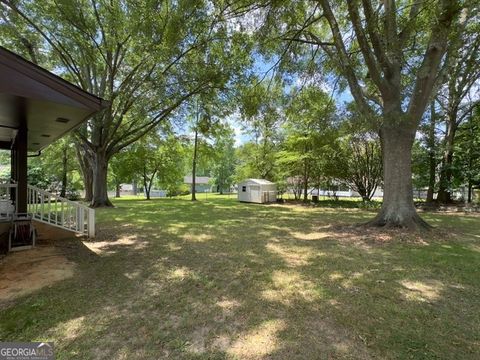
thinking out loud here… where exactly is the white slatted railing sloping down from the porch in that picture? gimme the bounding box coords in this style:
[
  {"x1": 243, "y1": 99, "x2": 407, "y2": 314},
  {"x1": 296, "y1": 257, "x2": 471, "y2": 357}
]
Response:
[{"x1": 27, "y1": 185, "x2": 95, "y2": 237}]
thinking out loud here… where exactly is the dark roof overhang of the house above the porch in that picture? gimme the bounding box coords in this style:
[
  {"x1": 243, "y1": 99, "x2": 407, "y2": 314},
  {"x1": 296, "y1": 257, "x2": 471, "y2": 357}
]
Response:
[{"x1": 0, "y1": 47, "x2": 108, "y2": 151}]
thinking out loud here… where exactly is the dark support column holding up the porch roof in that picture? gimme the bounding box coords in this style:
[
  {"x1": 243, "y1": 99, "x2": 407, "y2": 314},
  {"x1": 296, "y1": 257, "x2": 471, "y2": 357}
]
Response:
[{"x1": 14, "y1": 112, "x2": 28, "y2": 213}]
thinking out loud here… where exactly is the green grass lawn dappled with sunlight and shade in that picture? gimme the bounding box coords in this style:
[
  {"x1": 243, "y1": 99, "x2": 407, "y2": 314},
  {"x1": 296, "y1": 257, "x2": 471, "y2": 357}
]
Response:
[{"x1": 0, "y1": 194, "x2": 480, "y2": 359}]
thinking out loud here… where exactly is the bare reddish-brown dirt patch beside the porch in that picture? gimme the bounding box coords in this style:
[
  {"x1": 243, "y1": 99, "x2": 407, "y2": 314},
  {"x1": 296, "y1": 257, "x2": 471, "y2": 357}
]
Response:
[{"x1": 0, "y1": 246, "x2": 75, "y2": 306}]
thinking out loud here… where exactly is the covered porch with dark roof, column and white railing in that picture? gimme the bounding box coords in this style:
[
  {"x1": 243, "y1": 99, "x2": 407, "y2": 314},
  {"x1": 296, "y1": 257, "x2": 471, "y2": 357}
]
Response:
[{"x1": 0, "y1": 47, "x2": 107, "y2": 249}]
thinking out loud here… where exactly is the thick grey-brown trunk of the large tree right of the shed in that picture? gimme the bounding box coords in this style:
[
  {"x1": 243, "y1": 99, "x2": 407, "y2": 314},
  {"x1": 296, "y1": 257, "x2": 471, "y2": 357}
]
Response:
[{"x1": 367, "y1": 123, "x2": 429, "y2": 229}]
